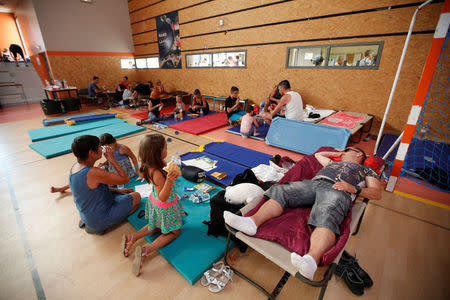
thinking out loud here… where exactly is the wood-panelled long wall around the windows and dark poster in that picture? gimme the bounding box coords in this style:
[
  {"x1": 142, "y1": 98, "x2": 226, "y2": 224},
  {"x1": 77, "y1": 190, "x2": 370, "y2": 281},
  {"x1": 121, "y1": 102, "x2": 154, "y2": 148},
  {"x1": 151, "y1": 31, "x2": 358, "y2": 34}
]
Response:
[{"x1": 126, "y1": 0, "x2": 442, "y2": 131}]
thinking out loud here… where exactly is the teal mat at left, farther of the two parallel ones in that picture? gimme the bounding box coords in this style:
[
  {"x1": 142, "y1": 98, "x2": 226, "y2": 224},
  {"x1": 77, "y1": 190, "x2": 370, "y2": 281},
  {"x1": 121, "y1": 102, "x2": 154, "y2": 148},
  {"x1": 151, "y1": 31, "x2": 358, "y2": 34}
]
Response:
[{"x1": 28, "y1": 119, "x2": 125, "y2": 142}]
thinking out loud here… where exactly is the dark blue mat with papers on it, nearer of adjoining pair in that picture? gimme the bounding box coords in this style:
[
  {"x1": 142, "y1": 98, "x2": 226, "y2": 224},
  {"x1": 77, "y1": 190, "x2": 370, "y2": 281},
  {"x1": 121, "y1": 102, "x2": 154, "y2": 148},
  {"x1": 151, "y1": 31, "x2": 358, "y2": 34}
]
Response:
[{"x1": 180, "y1": 152, "x2": 248, "y2": 186}]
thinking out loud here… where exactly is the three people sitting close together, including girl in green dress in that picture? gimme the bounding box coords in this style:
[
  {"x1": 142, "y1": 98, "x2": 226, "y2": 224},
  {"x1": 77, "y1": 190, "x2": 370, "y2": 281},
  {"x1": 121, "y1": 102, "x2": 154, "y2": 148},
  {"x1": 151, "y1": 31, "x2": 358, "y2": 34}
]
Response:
[{"x1": 51, "y1": 133, "x2": 185, "y2": 276}]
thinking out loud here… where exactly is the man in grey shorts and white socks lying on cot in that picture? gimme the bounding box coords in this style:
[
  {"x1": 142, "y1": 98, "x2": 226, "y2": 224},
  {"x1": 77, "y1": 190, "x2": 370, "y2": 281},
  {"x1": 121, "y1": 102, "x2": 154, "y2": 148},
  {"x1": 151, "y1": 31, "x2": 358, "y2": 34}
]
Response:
[{"x1": 223, "y1": 147, "x2": 381, "y2": 280}]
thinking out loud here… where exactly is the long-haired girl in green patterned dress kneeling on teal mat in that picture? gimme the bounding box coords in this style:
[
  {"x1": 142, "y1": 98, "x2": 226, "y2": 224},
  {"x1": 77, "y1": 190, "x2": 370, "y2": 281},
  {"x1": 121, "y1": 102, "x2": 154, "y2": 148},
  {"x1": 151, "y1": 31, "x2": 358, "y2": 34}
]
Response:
[{"x1": 121, "y1": 134, "x2": 183, "y2": 276}]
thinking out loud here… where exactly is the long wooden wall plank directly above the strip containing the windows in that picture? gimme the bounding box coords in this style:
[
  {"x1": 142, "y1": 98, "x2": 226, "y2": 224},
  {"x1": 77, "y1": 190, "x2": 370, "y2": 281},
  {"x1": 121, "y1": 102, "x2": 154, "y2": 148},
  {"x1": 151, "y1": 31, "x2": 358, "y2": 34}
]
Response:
[{"x1": 180, "y1": 8, "x2": 440, "y2": 50}]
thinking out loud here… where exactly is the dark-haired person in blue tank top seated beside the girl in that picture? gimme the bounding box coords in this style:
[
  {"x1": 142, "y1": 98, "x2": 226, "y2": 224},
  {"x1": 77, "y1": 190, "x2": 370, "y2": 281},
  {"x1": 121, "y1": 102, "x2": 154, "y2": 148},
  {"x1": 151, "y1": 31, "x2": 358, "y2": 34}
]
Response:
[{"x1": 69, "y1": 135, "x2": 141, "y2": 234}]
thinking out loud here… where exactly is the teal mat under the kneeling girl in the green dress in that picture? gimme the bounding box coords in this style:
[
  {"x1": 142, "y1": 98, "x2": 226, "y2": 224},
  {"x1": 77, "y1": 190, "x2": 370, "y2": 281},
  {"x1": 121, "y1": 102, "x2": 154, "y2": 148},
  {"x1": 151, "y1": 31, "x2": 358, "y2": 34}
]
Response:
[{"x1": 126, "y1": 176, "x2": 232, "y2": 285}]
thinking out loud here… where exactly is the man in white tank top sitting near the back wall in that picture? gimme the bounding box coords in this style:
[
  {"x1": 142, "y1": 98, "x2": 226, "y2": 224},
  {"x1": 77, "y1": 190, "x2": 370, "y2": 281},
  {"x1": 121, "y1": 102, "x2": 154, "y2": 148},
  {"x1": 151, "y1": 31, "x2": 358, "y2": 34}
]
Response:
[{"x1": 262, "y1": 80, "x2": 303, "y2": 125}]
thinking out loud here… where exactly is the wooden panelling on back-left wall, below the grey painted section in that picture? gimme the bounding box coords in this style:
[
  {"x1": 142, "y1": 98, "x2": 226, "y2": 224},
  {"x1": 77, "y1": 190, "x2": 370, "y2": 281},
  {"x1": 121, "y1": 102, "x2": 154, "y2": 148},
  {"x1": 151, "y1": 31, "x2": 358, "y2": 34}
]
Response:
[{"x1": 48, "y1": 55, "x2": 137, "y2": 90}]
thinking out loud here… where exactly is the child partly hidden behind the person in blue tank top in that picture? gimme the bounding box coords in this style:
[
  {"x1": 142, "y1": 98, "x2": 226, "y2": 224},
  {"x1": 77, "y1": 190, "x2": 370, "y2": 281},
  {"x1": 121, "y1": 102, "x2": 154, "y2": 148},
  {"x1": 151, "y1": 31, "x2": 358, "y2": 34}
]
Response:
[{"x1": 99, "y1": 133, "x2": 139, "y2": 178}]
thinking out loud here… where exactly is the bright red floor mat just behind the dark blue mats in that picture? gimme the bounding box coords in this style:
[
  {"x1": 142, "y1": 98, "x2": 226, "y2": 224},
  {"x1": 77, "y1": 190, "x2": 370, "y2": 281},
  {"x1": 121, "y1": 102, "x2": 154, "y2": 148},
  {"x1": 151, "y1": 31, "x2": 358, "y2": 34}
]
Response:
[{"x1": 169, "y1": 113, "x2": 228, "y2": 135}]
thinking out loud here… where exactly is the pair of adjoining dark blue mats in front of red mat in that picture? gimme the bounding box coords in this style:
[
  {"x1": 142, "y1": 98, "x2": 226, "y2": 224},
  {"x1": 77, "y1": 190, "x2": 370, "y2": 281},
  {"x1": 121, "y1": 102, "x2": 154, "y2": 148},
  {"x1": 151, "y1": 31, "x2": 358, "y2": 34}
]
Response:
[{"x1": 180, "y1": 142, "x2": 272, "y2": 186}]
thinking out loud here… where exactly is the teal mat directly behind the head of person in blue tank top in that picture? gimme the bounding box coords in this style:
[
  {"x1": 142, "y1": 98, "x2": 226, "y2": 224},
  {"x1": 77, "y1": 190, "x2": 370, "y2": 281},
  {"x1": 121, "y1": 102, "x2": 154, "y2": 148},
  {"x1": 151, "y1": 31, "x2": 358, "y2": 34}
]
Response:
[{"x1": 29, "y1": 122, "x2": 145, "y2": 158}]
